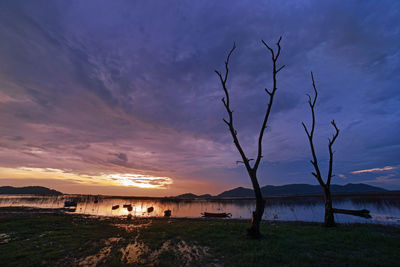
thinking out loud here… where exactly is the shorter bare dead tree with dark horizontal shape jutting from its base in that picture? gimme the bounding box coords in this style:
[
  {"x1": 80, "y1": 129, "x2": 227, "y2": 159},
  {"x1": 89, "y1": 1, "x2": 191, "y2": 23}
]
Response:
[{"x1": 302, "y1": 72, "x2": 371, "y2": 227}]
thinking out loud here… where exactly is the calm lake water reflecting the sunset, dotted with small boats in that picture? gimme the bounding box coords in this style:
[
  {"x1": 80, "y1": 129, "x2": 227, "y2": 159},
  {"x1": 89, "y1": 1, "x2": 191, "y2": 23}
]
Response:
[{"x1": 0, "y1": 194, "x2": 400, "y2": 225}]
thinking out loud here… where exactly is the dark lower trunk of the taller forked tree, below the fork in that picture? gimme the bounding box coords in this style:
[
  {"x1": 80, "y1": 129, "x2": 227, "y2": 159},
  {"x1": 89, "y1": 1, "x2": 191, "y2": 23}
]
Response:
[{"x1": 247, "y1": 174, "x2": 265, "y2": 238}]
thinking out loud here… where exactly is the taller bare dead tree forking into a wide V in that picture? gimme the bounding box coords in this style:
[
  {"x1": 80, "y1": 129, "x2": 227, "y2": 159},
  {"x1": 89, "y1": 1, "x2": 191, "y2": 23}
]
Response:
[{"x1": 215, "y1": 37, "x2": 285, "y2": 238}]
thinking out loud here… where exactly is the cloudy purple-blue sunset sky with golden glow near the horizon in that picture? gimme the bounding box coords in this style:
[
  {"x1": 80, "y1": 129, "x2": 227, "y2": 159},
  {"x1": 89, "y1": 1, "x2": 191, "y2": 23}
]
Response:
[{"x1": 0, "y1": 0, "x2": 400, "y2": 196}]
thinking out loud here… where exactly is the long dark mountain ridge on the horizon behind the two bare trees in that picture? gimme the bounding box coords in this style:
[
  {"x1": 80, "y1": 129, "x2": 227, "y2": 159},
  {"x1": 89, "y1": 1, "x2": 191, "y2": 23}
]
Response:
[{"x1": 216, "y1": 184, "x2": 388, "y2": 198}]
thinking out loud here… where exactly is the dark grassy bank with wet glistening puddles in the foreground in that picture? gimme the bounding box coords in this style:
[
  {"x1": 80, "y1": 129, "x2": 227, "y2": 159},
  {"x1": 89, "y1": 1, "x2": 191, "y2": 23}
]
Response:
[{"x1": 0, "y1": 212, "x2": 400, "y2": 266}]
